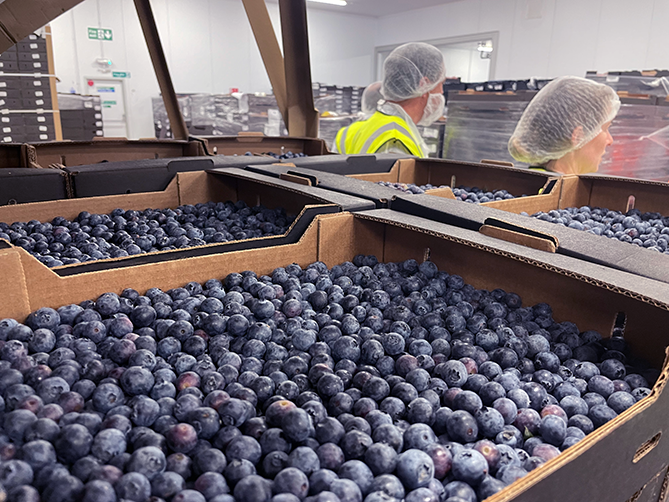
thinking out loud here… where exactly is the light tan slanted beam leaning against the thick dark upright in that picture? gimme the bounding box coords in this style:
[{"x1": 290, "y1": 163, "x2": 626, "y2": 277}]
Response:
[{"x1": 242, "y1": 0, "x2": 288, "y2": 127}]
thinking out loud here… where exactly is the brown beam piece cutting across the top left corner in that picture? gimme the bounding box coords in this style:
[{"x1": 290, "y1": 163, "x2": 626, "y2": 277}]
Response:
[{"x1": 0, "y1": 0, "x2": 83, "y2": 53}]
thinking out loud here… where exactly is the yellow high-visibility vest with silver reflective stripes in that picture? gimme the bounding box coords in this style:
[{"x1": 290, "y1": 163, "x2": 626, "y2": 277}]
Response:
[{"x1": 335, "y1": 112, "x2": 427, "y2": 158}]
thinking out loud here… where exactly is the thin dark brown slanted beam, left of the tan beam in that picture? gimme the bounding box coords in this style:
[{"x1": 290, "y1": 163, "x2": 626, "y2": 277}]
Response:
[{"x1": 134, "y1": 0, "x2": 188, "y2": 140}]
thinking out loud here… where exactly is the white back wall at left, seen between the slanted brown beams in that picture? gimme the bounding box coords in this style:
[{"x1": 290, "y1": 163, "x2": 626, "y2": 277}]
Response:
[{"x1": 51, "y1": 0, "x2": 376, "y2": 138}]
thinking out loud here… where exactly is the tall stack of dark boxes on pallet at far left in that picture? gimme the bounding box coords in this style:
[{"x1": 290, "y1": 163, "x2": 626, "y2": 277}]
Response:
[{"x1": 0, "y1": 34, "x2": 60, "y2": 143}]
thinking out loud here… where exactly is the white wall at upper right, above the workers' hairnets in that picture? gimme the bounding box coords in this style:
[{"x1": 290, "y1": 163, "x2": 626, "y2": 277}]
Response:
[{"x1": 376, "y1": 0, "x2": 669, "y2": 80}]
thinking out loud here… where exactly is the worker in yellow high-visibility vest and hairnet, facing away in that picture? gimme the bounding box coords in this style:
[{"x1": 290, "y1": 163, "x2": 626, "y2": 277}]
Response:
[{"x1": 334, "y1": 43, "x2": 446, "y2": 157}]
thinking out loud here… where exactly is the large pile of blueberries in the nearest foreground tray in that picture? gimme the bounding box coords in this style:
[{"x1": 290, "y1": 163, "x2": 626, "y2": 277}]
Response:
[{"x1": 0, "y1": 255, "x2": 658, "y2": 502}]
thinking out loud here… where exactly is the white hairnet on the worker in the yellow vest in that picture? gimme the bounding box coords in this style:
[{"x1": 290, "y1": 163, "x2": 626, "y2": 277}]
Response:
[{"x1": 381, "y1": 42, "x2": 446, "y2": 101}]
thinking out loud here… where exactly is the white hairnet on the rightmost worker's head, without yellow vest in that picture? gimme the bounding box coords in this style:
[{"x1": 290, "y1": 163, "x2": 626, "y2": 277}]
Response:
[{"x1": 509, "y1": 77, "x2": 620, "y2": 165}]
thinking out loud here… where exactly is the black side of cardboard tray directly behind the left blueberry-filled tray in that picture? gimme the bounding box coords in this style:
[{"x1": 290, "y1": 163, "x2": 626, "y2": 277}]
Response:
[{"x1": 65, "y1": 155, "x2": 276, "y2": 197}]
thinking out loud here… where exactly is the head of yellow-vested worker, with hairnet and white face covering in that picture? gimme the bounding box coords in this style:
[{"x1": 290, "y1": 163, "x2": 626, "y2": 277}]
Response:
[{"x1": 381, "y1": 42, "x2": 446, "y2": 125}]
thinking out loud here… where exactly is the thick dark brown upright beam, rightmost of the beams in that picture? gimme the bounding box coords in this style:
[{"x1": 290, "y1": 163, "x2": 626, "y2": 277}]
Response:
[{"x1": 279, "y1": 0, "x2": 318, "y2": 138}]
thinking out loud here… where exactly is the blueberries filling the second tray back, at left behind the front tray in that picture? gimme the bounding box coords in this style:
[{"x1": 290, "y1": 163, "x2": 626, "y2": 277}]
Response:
[{"x1": 0, "y1": 201, "x2": 295, "y2": 267}]
